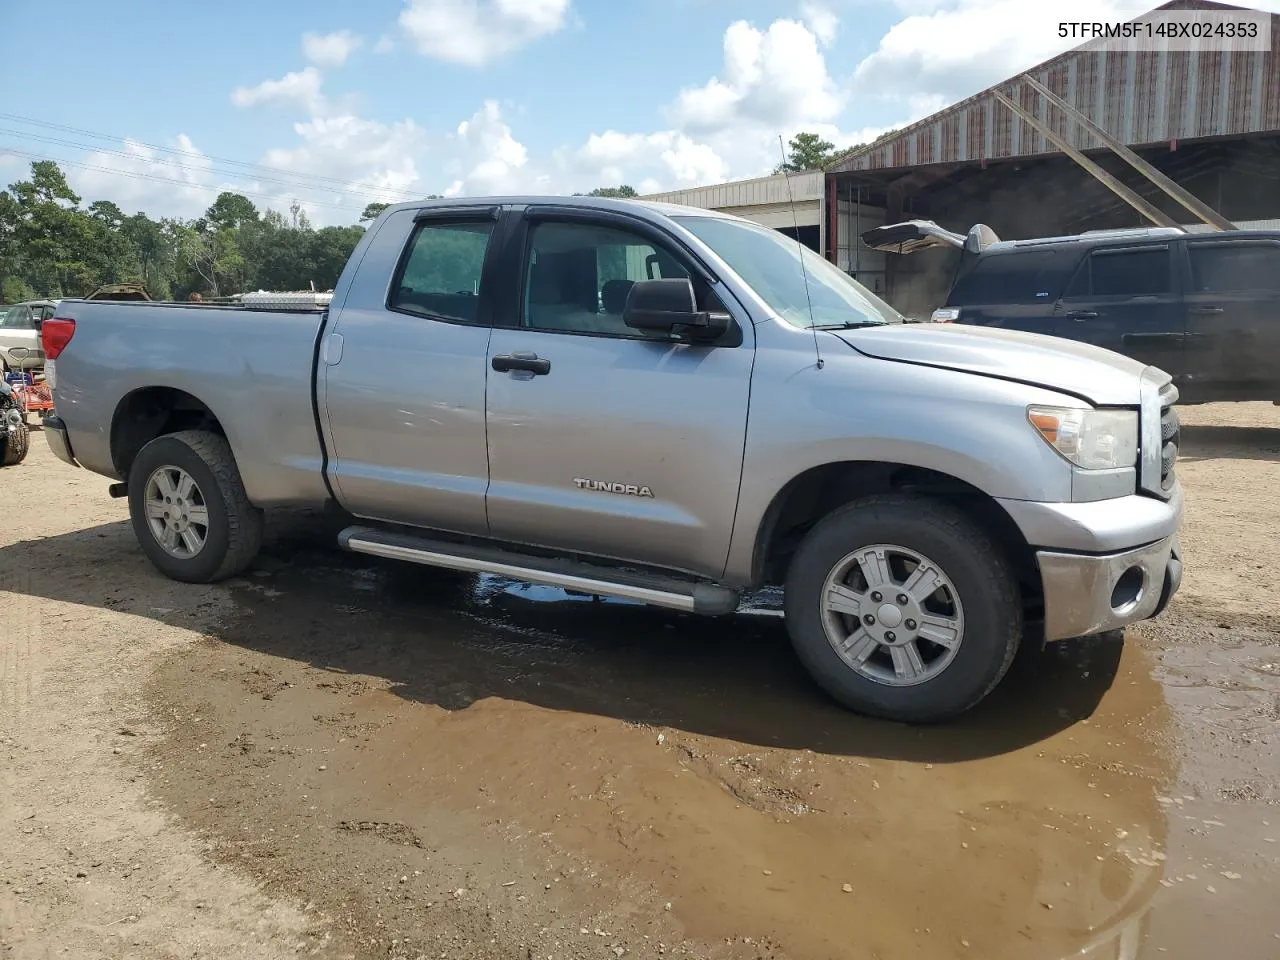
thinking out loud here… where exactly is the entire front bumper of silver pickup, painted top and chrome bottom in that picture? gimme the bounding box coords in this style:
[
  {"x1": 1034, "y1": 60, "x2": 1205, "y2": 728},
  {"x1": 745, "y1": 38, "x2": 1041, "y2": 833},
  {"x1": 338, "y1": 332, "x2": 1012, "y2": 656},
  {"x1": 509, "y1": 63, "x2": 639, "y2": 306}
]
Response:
[{"x1": 1001, "y1": 486, "x2": 1183, "y2": 640}]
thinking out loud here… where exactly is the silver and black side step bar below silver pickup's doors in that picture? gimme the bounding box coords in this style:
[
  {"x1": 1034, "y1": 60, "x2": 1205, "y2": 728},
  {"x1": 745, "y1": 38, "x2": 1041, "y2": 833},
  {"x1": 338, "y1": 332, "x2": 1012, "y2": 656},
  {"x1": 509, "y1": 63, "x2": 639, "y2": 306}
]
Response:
[{"x1": 338, "y1": 526, "x2": 740, "y2": 617}]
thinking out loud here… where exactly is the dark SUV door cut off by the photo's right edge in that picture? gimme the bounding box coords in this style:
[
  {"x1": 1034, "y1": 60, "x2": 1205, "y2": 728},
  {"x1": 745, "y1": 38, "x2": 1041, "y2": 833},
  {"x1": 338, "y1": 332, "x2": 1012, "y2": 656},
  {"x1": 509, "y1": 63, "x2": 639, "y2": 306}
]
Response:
[{"x1": 1185, "y1": 238, "x2": 1280, "y2": 399}]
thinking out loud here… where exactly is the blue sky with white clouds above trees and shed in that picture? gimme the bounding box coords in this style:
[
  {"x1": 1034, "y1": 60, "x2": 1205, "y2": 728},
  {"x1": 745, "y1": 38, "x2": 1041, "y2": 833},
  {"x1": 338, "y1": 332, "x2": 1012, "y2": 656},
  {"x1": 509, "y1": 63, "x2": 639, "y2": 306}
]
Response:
[{"x1": 0, "y1": 0, "x2": 1280, "y2": 223}]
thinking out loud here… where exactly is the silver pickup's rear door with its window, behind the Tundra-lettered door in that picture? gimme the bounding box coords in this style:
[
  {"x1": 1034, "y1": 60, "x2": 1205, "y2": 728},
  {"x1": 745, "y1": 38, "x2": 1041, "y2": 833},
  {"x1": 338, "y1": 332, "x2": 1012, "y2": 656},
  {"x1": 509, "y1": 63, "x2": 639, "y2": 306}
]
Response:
[{"x1": 320, "y1": 210, "x2": 498, "y2": 535}]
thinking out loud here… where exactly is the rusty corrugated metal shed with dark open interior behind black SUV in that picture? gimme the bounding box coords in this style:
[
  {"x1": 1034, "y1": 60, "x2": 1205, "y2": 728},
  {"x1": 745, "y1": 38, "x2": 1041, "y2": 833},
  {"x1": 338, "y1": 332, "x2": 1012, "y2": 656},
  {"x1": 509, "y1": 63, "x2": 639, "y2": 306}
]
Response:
[{"x1": 826, "y1": 0, "x2": 1280, "y2": 312}]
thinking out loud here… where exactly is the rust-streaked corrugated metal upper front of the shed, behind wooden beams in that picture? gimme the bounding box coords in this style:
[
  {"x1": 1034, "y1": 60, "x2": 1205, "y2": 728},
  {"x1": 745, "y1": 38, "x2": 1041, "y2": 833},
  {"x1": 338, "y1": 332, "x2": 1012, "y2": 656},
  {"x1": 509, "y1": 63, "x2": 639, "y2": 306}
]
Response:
[{"x1": 827, "y1": 0, "x2": 1280, "y2": 173}]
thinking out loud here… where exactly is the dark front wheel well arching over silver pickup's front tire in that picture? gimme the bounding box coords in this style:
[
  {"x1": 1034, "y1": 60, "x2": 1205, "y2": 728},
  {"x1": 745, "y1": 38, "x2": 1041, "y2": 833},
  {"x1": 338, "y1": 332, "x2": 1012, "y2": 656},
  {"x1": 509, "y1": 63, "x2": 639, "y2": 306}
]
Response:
[{"x1": 753, "y1": 461, "x2": 1041, "y2": 600}]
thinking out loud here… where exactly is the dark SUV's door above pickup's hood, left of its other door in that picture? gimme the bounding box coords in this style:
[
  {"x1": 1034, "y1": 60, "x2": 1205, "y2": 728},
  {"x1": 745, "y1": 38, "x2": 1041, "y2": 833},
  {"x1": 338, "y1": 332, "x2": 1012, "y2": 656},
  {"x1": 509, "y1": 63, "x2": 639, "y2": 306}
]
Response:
[{"x1": 1056, "y1": 243, "x2": 1187, "y2": 379}]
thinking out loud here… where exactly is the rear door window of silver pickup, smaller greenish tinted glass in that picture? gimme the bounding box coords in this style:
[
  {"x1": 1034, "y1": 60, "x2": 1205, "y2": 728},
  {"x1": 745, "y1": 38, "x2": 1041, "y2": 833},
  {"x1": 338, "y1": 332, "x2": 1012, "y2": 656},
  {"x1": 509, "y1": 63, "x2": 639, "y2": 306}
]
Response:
[{"x1": 390, "y1": 220, "x2": 493, "y2": 323}]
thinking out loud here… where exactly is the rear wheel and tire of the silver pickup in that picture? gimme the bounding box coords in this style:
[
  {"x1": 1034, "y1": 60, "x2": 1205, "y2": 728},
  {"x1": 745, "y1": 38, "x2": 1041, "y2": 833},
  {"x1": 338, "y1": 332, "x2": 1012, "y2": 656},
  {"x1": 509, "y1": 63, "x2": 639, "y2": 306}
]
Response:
[{"x1": 128, "y1": 430, "x2": 262, "y2": 584}]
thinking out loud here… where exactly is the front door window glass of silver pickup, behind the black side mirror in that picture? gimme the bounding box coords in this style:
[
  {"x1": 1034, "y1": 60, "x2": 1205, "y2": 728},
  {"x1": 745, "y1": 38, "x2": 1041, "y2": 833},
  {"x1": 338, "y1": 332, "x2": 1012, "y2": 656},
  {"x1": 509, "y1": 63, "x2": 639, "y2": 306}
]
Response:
[{"x1": 522, "y1": 223, "x2": 689, "y2": 338}]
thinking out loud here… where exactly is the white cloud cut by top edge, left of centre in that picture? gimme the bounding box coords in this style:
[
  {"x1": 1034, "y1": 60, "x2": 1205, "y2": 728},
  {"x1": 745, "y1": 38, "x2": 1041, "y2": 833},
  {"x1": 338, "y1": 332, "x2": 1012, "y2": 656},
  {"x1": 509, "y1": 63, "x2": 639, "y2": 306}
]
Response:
[{"x1": 399, "y1": 0, "x2": 570, "y2": 67}]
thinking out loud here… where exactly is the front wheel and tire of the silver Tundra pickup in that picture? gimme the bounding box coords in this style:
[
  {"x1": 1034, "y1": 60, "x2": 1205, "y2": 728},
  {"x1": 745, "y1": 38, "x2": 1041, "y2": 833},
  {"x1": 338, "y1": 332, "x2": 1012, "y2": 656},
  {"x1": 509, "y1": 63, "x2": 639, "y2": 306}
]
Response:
[{"x1": 786, "y1": 495, "x2": 1023, "y2": 723}]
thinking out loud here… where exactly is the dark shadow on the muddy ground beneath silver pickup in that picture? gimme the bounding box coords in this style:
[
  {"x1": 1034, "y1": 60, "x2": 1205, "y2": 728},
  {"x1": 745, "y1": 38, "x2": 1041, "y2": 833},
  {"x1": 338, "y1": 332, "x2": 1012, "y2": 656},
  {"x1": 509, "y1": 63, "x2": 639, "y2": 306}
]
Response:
[{"x1": 0, "y1": 515, "x2": 1123, "y2": 763}]
